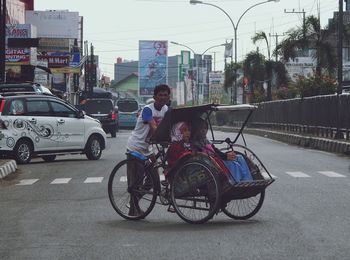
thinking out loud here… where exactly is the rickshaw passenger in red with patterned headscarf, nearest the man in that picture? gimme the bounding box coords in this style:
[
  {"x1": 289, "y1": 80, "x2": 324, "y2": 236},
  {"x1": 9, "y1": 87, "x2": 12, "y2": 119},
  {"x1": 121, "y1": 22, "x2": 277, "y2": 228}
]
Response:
[{"x1": 167, "y1": 122, "x2": 191, "y2": 168}]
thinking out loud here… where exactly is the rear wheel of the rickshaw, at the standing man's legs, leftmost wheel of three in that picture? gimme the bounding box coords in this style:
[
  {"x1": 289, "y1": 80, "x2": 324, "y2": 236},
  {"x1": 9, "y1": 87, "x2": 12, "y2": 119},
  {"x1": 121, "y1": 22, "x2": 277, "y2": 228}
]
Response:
[{"x1": 108, "y1": 159, "x2": 158, "y2": 220}]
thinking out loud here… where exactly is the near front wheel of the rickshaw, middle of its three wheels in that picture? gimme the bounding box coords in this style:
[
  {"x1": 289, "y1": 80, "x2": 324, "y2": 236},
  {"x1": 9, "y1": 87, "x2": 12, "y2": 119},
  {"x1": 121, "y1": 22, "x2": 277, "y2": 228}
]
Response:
[{"x1": 170, "y1": 162, "x2": 220, "y2": 224}]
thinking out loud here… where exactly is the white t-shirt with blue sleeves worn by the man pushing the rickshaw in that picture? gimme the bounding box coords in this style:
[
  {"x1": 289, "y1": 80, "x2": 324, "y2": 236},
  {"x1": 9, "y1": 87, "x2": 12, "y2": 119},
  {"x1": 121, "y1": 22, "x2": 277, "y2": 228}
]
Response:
[{"x1": 126, "y1": 103, "x2": 168, "y2": 155}]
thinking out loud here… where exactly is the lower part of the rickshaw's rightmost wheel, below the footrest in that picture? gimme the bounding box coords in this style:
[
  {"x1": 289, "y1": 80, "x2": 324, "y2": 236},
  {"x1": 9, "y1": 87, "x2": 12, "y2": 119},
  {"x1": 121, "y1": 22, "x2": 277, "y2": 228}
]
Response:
[{"x1": 222, "y1": 190, "x2": 265, "y2": 220}]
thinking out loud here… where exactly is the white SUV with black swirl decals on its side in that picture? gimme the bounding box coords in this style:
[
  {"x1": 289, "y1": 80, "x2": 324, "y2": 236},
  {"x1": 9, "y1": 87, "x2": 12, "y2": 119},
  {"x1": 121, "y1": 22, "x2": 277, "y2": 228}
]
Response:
[{"x1": 0, "y1": 95, "x2": 106, "y2": 164}]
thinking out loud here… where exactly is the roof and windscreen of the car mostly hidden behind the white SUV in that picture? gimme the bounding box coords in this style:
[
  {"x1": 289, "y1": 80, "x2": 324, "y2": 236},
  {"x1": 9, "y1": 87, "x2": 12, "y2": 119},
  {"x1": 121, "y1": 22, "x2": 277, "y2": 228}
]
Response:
[{"x1": 0, "y1": 83, "x2": 52, "y2": 95}]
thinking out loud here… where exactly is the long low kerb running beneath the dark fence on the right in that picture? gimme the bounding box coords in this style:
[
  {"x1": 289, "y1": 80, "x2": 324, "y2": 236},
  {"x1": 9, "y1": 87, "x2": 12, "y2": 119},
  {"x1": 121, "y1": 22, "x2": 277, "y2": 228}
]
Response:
[{"x1": 213, "y1": 126, "x2": 350, "y2": 156}]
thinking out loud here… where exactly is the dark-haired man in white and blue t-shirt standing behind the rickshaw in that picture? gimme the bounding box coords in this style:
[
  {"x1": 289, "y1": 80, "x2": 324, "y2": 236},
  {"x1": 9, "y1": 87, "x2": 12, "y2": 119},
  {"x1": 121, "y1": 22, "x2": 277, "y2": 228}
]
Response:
[{"x1": 126, "y1": 84, "x2": 170, "y2": 216}]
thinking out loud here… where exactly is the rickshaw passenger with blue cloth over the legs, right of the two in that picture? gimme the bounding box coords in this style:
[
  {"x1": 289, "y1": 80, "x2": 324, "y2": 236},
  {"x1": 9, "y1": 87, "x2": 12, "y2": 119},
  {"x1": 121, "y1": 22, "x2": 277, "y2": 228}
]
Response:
[{"x1": 192, "y1": 119, "x2": 253, "y2": 184}]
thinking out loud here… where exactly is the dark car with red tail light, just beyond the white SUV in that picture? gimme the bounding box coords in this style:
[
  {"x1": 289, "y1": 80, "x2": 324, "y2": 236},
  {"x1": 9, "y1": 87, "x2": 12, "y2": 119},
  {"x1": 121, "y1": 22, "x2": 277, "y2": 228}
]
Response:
[{"x1": 80, "y1": 98, "x2": 119, "y2": 137}]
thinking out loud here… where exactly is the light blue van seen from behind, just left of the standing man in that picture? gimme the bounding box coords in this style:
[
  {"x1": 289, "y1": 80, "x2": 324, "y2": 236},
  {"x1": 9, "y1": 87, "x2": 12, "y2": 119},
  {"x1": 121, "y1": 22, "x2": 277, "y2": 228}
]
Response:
[{"x1": 116, "y1": 98, "x2": 140, "y2": 128}]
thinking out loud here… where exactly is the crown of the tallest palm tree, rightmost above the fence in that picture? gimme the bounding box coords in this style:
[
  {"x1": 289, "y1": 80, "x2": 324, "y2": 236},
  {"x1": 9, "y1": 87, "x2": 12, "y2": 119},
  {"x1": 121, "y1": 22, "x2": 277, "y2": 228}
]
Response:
[{"x1": 276, "y1": 16, "x2": 337, "y2": 75}]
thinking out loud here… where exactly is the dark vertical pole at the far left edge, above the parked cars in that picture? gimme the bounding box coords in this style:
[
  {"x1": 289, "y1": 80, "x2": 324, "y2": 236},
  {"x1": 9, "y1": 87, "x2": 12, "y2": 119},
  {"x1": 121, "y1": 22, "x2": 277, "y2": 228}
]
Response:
[{"x1": 0, "y1": 0, "x2": 6, "y2": 83}]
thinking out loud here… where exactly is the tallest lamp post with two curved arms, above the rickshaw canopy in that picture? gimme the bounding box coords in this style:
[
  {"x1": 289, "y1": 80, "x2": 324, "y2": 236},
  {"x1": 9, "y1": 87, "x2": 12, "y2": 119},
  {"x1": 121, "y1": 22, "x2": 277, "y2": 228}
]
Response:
[{"x1": 190, "y1": 0, "x2": 279, "y2": 103}]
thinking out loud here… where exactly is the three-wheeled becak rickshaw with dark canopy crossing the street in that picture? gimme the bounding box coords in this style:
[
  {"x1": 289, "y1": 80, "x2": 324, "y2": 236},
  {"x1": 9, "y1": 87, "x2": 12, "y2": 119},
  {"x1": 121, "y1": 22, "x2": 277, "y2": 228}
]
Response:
[{"x1": 108, "y1": 104, "x2": 274, "y2": 224}]
